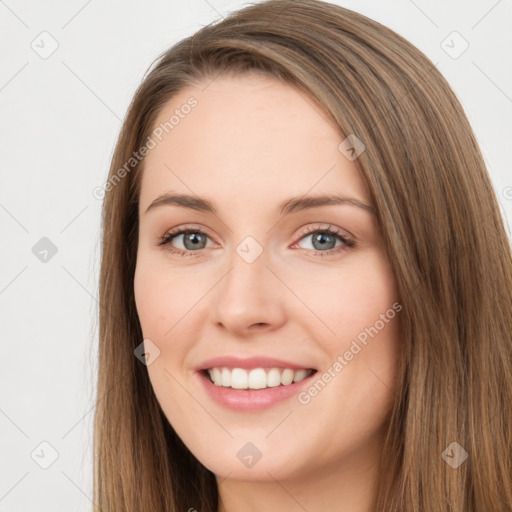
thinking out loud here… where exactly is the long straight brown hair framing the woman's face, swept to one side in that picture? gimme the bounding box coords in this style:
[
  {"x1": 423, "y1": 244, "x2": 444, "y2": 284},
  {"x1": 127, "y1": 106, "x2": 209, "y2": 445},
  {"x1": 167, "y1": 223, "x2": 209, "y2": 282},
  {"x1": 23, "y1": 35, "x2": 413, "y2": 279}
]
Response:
[{"x1": 93, "y1": 0, "x2": 512, "y2": 512}]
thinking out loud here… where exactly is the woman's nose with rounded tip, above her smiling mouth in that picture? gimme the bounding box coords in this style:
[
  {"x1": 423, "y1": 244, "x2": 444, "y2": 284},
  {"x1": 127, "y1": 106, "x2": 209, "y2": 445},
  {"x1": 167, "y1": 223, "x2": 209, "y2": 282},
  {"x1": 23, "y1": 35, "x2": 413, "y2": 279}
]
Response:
[{"x1": 210, "y1": 246, "x2": 289, "y2": 338}]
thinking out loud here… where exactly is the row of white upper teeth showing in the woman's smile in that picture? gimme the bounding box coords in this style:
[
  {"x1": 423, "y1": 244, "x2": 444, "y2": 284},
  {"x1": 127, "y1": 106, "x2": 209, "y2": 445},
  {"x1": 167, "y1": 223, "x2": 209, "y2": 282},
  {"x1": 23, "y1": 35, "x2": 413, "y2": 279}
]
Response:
[{"x1": 208, "y1": 368, "x2": 314, "y2": 389}]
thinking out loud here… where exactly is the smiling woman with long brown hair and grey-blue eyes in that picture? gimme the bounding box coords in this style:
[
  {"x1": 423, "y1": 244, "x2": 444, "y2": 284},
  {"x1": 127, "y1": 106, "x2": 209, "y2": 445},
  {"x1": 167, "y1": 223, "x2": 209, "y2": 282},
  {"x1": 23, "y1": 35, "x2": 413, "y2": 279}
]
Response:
[{"x1": 94, "y1": 0, "x2": 512, "y2": 512}]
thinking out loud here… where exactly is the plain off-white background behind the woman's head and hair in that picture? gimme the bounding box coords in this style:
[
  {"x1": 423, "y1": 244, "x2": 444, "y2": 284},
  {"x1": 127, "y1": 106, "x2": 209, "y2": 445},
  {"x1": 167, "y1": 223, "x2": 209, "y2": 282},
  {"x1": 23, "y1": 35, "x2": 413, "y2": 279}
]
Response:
[{"x1": 0, "y1": 0, "x2": 512, "y2": 512}]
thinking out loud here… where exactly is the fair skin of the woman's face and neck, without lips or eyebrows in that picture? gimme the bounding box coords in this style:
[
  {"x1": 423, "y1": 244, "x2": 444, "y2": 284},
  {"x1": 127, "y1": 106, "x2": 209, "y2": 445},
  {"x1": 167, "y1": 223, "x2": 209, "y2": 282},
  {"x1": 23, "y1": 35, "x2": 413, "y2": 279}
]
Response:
[{"x1": 134, "y1": 74, "x2": 399, "y2": 512}]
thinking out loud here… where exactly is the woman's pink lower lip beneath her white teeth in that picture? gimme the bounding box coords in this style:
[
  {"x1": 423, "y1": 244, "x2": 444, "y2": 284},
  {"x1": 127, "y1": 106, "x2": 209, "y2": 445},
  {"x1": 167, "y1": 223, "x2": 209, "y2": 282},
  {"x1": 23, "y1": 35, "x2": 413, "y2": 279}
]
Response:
[{"x1": 198, "y1": 372, "x2": 316, "y2": 411}]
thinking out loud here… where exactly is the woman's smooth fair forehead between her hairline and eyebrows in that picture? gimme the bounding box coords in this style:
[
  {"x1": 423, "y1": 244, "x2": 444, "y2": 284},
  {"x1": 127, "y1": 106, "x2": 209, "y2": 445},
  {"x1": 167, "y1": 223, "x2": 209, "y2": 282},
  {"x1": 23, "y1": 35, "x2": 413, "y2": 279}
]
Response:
[{"x1": 140, "y1": 74, "x2": 368, "y2": 207}]
